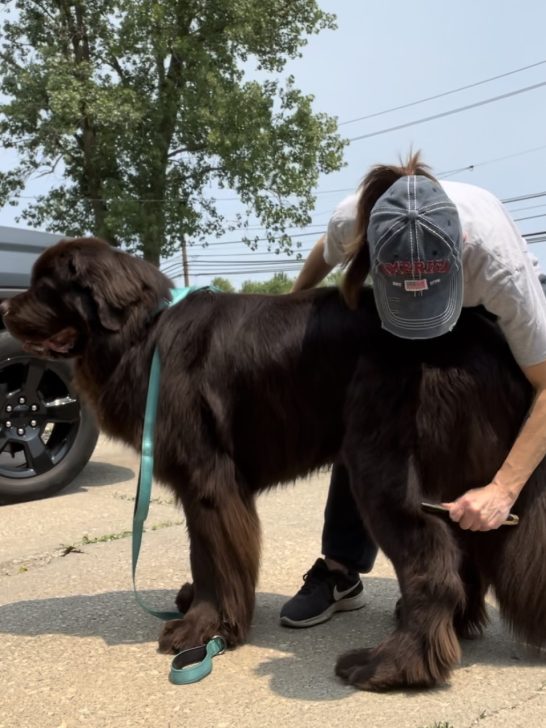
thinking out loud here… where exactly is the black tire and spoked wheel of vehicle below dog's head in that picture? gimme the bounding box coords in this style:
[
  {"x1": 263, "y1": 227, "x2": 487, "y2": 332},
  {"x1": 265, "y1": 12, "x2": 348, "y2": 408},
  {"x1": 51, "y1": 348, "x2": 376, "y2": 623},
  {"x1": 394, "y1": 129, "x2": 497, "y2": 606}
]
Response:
[{"x1": 0, "y1": 332, "x2": 99, "y2": 503}]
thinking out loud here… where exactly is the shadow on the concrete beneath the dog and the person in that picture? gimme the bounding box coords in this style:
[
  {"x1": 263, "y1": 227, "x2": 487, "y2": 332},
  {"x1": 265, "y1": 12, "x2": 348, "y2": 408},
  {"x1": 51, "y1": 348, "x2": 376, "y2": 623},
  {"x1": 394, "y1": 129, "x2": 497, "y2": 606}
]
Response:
[{"x1": 0, "y1": 577, "x2": 540, "y2": 700}]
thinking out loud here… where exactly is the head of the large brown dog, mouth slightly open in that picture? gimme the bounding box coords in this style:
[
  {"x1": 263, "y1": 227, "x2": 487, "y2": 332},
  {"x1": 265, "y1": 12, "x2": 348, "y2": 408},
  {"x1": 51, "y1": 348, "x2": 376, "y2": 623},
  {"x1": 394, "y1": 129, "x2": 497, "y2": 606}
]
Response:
[{"x1": 1, "y1": 238, "x2": 171, "y2": 357}]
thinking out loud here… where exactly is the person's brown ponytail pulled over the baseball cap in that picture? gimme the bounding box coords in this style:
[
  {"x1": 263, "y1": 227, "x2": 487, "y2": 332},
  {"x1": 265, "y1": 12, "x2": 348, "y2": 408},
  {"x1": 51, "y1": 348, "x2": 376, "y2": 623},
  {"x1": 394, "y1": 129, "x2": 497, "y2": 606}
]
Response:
[{"x1": 341, "y1": 152, "x2": 434, "y2": 308}]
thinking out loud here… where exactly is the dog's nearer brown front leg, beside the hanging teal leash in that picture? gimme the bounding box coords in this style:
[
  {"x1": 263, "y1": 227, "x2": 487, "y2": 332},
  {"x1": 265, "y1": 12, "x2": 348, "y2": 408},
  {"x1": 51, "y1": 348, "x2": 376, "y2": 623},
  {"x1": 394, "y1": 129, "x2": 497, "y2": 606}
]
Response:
[{"x1": 159, "y1": 464, "x2": 260, "y2": 652}]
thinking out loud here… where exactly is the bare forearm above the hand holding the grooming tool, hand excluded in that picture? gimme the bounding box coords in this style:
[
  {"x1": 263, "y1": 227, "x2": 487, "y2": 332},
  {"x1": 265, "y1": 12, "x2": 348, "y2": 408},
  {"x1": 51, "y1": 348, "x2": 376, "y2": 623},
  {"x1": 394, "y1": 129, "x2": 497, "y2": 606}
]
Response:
[{"x1": 492, "y1": 389, "x2": 546, "y2": 501}]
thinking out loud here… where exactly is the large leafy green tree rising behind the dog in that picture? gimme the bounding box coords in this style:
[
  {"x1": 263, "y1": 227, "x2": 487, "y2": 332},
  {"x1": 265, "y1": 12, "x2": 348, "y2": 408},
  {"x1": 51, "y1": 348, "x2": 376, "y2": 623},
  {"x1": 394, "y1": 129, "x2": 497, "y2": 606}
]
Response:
[{"x1": 0, "y1": 0, "x2": 344, "y2": 263}]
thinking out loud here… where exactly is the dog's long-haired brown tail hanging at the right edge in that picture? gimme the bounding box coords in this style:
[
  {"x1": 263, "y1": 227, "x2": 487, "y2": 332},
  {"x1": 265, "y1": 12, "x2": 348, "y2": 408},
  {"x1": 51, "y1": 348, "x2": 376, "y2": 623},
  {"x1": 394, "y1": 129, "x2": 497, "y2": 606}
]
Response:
[{"x1": 491, "y1": 472, "x2": 546, "y2": 647}]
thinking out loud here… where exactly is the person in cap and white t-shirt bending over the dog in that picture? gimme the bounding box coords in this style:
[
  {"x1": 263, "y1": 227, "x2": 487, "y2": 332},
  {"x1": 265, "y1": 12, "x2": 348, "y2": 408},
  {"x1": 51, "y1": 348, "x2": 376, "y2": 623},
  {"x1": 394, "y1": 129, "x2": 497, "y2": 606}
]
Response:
[{"x1": 280, "y1": 153, "x2": 546, "y2": 627}]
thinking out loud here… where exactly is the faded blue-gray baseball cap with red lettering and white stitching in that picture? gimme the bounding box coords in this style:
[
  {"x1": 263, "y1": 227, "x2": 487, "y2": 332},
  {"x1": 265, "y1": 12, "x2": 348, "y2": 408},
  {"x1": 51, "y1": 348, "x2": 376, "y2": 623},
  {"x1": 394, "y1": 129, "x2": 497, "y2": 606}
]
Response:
[{"x1": 368, "y1": 175, "x2": 463, "y2": 339}]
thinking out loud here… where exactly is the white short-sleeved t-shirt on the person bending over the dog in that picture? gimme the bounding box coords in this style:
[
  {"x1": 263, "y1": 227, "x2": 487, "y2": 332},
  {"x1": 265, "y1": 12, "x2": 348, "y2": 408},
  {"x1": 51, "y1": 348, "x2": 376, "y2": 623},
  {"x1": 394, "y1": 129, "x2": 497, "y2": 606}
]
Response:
[{"x1": 324, "y1": 182, "x2": 546, "y2": 366}]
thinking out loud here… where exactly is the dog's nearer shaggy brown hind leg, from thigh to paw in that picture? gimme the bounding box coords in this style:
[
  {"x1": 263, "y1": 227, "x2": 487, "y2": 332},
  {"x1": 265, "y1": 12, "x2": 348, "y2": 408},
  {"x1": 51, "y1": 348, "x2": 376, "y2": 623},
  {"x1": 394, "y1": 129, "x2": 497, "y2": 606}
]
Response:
[{"x1": 336, "y1": 388, "x2": 465, "y2": 690}]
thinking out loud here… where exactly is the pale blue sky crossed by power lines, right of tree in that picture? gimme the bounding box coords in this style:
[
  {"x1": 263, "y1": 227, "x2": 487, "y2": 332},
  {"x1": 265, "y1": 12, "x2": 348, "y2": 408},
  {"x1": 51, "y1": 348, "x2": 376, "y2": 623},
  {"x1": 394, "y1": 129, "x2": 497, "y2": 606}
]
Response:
[{"x1": 0, "y1": 0, "x2": 546, "y2": 285}]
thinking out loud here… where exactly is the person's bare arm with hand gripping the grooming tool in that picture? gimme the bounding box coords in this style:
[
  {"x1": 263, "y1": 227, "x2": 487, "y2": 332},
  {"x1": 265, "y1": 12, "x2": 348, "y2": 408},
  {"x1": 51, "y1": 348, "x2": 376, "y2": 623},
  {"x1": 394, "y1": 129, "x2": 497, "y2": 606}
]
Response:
[{"x1": 444, "y1": 362, "x2": 546, "y2": 531}]
